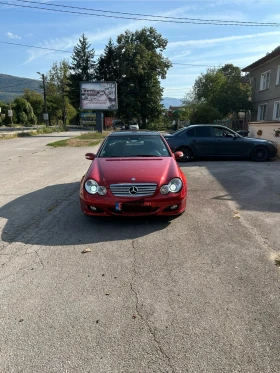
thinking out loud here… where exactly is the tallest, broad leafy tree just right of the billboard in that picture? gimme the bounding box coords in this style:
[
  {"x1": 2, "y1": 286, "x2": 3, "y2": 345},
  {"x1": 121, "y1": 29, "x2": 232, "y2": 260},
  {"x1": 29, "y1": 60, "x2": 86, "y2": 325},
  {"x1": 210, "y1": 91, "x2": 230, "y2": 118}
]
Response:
[{"x1": 96, "y1": 27, "x2": 172, "y2": 127}]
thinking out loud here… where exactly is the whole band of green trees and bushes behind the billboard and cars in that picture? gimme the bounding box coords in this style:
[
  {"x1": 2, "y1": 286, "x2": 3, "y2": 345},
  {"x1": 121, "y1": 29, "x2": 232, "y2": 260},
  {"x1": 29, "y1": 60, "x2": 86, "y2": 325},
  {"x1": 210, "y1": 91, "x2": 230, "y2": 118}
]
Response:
[{"x1": 0, "y1": 27, "x2": 251, "y2": 131}]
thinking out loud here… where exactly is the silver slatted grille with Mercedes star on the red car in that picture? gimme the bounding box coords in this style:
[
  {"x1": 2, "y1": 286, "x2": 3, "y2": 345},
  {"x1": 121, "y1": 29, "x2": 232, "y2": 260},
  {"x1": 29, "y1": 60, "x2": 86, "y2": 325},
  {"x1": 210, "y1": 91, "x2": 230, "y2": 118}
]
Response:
[{"x1": 110, "y1": 184, "x2": 157, "y2": 197}]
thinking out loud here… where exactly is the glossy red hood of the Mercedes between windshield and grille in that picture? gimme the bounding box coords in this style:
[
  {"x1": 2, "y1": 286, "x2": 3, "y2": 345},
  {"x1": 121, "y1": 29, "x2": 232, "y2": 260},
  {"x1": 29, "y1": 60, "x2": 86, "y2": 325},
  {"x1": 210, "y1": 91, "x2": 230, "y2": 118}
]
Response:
[{"x1": 87, "y1": 157, "x2": 180, "y2": 187}]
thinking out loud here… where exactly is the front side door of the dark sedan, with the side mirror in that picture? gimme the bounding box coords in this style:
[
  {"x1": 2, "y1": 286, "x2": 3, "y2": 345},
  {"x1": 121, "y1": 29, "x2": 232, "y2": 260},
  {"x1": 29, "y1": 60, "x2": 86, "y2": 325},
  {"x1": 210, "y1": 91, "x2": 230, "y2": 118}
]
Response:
[{"x1": 213, "y1": 127, "x2": 247, "y2": 157}]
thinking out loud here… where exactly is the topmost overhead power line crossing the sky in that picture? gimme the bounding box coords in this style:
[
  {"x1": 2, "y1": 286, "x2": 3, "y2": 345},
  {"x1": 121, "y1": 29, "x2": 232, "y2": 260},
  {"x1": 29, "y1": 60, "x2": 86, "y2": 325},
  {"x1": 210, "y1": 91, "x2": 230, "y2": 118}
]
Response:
[{"x1": 15, "y1": 0, "x2": 280, "y2": 26}]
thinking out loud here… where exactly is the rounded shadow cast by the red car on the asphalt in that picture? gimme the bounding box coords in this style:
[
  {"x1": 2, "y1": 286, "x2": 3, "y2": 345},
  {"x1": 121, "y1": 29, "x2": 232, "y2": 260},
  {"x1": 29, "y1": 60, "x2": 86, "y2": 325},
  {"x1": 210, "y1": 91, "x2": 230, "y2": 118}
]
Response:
[{"x1": 0, "y1": 182, "x2": 170, "y2": 246}]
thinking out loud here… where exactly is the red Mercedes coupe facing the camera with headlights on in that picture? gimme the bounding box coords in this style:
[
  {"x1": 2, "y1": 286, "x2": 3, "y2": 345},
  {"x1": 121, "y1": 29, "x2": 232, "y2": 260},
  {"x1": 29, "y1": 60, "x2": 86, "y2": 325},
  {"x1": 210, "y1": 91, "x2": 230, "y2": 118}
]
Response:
[{"x1": 80, "y1": 131, "x2": 187, "y2": 216}]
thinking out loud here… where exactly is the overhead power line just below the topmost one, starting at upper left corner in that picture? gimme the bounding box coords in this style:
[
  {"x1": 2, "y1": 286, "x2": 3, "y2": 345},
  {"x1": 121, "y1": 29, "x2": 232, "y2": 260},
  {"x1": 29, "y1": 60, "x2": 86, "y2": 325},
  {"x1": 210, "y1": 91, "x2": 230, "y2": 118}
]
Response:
[{"x1": 0, "y1": 0, "x2": 280, "y2": 27}]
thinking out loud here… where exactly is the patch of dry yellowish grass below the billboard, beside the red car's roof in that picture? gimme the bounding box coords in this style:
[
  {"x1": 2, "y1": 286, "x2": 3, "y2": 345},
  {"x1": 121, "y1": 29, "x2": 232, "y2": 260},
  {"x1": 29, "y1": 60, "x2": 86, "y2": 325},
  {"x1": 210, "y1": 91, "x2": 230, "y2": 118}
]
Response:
[{"x1": 47, "y1": 131, "x2": 109, "y2": 148}]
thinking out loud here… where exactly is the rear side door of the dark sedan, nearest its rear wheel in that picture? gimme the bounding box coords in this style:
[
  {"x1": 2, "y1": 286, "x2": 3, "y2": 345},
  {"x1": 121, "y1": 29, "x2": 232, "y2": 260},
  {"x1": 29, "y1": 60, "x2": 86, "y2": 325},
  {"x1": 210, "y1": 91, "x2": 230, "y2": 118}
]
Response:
[{"x1": 190, "y1": 126, "x2": 216, "y2": 156}]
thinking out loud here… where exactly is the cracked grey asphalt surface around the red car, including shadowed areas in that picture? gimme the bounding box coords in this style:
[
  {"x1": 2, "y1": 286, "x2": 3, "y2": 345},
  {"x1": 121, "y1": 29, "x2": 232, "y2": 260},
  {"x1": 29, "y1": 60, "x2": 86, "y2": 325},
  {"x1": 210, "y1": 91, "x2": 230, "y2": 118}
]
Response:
[{"x1": 0, "y1": 132, "x2": 280, "y2": 373}]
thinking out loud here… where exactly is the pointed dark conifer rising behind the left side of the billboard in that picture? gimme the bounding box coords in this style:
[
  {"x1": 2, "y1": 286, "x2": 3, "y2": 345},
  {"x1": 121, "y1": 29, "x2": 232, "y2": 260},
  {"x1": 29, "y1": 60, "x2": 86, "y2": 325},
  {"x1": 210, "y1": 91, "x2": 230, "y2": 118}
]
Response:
[{"x1": 68, "y1": 34, "x2": 95, "y2": 110}]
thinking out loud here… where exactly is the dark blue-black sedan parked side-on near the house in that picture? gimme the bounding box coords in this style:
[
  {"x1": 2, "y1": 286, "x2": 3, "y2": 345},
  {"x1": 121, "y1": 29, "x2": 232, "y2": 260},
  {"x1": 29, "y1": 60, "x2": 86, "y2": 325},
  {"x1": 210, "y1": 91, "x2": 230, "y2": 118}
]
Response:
[{"x1": 164, "y1": 124, "x2": 277, "y2": 162}]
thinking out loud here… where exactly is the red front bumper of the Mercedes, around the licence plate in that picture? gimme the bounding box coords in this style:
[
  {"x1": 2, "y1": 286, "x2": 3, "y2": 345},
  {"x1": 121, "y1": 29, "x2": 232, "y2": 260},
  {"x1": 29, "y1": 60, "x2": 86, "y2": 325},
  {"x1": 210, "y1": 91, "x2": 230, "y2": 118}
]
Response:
[{"x1": 80, "y1": 186, "x2": 187, "y2": 216}]
